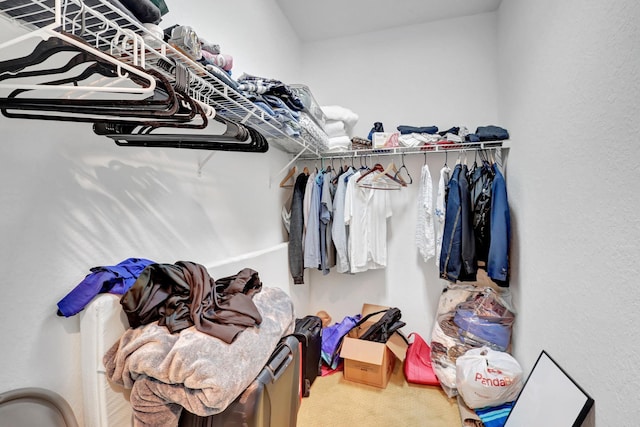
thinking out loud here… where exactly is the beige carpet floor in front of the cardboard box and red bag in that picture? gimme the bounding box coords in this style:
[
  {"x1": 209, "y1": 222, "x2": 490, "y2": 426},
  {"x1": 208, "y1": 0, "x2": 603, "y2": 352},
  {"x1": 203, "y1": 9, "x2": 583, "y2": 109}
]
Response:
[{"x1": 298, "y1": 361, "x2": 462, "y2": 427}]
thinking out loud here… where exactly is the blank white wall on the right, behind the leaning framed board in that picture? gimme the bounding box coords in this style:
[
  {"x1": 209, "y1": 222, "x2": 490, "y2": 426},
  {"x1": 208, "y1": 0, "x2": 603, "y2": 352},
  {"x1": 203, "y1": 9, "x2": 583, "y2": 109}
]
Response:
[{"x1": 498, "y1": 0, "x2": 640, "y2": 427}]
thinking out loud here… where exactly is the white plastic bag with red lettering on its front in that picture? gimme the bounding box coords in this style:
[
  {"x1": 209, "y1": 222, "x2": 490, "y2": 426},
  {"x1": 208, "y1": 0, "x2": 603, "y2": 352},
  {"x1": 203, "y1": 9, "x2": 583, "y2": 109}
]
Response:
[{"x1": 456, "y1": 347, "x2": 522, "y2": 409}]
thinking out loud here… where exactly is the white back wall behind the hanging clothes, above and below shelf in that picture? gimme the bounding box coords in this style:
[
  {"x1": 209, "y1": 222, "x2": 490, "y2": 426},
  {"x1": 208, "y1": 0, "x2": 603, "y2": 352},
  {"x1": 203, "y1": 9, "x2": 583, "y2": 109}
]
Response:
[{"x1": 303, "y1": 13, "x2": 500, "y2": 344}]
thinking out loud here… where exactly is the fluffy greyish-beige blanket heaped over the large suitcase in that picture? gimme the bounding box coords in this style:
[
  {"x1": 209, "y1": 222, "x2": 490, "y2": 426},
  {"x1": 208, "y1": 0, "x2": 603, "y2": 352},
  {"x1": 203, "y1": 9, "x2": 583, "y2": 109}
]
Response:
[{"x1": 103, "y1": 287, "x2": 295, "y2": 427}]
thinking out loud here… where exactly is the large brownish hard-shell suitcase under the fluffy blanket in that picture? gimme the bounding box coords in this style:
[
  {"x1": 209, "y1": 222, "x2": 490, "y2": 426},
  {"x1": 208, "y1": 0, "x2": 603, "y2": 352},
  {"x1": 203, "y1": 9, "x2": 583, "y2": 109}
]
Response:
[{"x1": 178, "y1": 336, "x2": 301, "y2": 427}]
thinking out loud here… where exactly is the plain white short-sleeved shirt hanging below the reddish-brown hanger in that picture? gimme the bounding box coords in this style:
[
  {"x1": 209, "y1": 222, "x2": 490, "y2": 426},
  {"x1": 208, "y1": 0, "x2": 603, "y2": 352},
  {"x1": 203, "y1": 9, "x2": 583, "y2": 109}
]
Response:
[{"x1": 344, "y1": 172, "x2": 392, "y2": 273}]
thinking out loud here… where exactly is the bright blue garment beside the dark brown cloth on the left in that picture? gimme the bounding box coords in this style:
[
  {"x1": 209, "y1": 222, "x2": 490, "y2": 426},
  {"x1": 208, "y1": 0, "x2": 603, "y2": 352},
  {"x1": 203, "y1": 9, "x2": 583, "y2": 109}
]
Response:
[{"x1": 58, "y1": 258, "x2": 155, "y2": 317}]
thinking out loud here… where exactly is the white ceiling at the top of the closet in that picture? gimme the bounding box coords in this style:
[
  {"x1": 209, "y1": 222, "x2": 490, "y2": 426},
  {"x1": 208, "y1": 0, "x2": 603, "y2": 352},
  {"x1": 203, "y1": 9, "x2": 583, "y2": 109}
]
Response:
[{"x1": 276, "y1": 0, "x2": 502, "y2": 42}]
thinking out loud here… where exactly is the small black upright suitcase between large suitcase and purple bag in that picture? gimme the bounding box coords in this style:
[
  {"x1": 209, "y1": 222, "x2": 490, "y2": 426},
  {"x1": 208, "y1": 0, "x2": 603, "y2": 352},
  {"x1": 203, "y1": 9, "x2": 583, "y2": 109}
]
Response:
[{"x1": 293, "y1": 316, "x2": 322, "y2": 397}]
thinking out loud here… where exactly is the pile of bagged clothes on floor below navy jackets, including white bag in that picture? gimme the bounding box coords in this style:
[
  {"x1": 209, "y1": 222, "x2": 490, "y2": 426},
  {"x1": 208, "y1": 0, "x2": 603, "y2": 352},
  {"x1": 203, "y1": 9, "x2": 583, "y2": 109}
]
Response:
[{"x1": 431, "y1": 283, "x2": 522, "y2": 427}]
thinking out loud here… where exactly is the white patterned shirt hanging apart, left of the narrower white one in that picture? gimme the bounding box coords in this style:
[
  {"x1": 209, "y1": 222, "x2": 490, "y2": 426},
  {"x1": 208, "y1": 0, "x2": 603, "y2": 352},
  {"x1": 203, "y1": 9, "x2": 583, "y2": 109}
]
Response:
[{"x1": 416, "y1": 164, "x2": 436, "y2": 262}]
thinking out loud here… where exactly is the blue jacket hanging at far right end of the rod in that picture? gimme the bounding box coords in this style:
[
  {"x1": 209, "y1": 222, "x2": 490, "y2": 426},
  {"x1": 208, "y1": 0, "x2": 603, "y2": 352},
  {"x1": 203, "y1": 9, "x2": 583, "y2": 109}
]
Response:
[{"x1": 487, "y1": 164, "x2": 511, "y2": 287}]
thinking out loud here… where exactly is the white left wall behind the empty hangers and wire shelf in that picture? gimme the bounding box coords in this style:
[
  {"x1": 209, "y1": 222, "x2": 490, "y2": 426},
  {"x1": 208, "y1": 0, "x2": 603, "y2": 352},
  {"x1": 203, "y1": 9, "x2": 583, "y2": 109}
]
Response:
[{"x1": 0, "y1": 0, "x2": 299, "y2": 420}]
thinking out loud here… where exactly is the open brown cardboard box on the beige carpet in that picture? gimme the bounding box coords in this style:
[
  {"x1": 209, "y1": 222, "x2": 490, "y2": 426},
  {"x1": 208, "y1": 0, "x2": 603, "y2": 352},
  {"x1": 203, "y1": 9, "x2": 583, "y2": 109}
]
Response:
[{"x1": 340, "y1": 304, "x2": 407, "y2": 388}]
